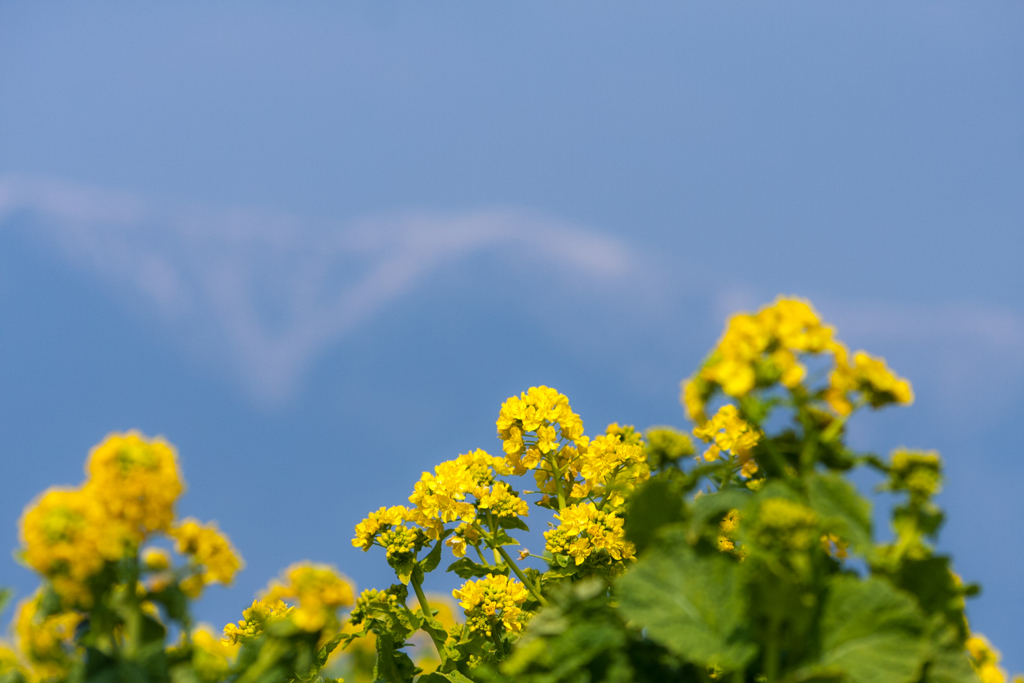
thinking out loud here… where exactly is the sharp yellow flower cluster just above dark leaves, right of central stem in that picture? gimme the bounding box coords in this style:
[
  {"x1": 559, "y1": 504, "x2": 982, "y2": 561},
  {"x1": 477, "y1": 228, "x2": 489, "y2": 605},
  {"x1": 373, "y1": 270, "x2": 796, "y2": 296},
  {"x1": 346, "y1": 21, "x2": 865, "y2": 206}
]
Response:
[{"x1": 544, "y1": 503, "x2": 636, "y2": 565}]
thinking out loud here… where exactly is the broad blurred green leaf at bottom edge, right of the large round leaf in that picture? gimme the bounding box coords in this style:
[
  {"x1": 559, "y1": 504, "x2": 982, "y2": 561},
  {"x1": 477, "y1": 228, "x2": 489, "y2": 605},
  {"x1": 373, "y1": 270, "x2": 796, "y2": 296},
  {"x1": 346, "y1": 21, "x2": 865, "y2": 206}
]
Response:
[{"x1": 820, "y1": 575, "x2": 928, "y2": 683}]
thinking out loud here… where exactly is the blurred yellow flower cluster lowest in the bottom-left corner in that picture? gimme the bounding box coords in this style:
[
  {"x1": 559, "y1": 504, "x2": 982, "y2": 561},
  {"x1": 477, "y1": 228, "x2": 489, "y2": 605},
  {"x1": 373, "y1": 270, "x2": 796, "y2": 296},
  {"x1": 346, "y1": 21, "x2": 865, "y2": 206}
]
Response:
[{"x1": 14, "y1": 592, "x2": 82, "y2": 680}]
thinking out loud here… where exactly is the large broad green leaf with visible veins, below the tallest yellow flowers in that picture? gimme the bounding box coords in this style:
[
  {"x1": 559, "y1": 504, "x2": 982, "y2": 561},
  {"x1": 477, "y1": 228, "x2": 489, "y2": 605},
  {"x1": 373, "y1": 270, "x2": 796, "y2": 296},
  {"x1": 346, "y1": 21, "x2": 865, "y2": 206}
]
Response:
[{"x1": 616, "y1": 533, "x2": 757, "y2": 670}]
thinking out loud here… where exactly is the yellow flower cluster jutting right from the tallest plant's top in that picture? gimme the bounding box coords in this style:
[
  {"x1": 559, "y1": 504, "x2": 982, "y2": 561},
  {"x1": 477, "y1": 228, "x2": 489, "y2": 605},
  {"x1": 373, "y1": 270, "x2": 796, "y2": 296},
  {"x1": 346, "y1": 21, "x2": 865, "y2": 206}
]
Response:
[{"x1": 825, "y1": 344, "x2": 913, "y2": 415}]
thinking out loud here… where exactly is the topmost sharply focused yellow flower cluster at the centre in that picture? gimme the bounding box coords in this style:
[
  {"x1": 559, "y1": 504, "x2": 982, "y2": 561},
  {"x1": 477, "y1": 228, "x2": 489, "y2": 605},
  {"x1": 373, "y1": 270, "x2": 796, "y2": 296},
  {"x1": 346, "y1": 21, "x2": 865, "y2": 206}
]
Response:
[{"x1": 497, "y1": 386, "x2": 588, "y2": 475}]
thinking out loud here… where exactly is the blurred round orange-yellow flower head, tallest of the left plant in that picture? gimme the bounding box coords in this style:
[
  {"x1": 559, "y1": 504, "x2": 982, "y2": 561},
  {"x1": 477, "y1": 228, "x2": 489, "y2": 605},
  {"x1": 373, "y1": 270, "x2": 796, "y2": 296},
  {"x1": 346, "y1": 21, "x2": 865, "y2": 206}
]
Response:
[{"x1": 85, "y1": 431, "x2": 183, "y2": 543}]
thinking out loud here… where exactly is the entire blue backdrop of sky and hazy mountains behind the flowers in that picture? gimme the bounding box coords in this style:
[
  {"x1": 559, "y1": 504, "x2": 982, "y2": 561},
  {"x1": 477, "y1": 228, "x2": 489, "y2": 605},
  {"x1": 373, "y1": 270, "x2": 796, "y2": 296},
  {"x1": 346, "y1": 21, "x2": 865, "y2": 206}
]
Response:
[{"x1": 0, "y1": 0, "x2": 1024, "y2": 671}]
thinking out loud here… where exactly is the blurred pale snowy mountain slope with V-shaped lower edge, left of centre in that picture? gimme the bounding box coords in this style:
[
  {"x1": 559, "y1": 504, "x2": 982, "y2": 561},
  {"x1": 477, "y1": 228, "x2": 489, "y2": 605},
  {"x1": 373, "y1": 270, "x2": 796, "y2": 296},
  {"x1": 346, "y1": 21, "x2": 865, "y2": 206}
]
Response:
[{"x1": 0, "y1": 176, "x2": 649, "y2": 401}]
